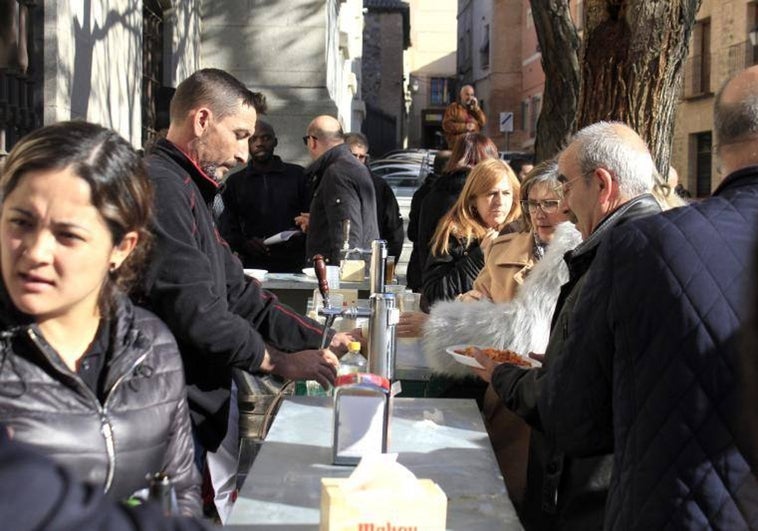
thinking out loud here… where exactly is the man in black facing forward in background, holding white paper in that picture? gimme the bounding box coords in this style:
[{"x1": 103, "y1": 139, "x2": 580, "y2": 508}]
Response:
[{"x1": 219, "y1": 120, "x2": 311, "y2": 273}]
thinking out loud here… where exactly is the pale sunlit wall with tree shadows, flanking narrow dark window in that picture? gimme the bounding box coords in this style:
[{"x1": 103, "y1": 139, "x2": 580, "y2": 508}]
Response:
[{"x1": 43, "y1": 0, "x2": 199, "y2": 147}]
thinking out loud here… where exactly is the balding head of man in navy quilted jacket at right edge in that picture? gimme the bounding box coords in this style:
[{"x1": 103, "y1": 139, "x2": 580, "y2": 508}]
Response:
[{"x1": 713, "y1": 66, "x2": 758, "y2": 173}]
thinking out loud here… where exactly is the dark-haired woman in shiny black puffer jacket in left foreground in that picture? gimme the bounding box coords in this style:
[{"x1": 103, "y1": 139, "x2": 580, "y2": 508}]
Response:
[{"x1": 0, "y1": 122, "x2": 200, "y2": 515}]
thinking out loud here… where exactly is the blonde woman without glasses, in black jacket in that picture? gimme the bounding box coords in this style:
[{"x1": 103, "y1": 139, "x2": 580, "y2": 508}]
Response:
[{"x1": 423, "y1": 159, "x2": 521, "y2": 305}]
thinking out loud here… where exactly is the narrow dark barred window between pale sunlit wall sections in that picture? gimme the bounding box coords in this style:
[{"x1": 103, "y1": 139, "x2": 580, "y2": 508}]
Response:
[{"x1": 142, "y1": 0, "x2": 163, "y2": 145}]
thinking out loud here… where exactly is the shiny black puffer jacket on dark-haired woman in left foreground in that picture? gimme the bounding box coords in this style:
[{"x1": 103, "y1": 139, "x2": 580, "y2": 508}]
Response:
[{"x1": 0, "y1": 293, "x2": 200, "y2": 515}]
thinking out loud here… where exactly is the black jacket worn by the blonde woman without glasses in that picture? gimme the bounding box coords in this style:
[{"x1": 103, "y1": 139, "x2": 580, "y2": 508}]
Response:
[{"x1": 423, "y1": 236, "x2": 484, "y2": 306}]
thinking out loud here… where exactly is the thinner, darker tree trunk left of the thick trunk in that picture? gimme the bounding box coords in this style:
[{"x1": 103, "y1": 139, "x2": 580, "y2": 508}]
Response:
[{"x1": 530, "y1": 0, "x2": 580, "y2": 162}]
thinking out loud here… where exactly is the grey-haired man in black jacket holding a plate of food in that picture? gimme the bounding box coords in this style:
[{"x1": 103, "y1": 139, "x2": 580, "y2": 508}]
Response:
[{"x1": 477, "y1": 122, "x2": 661, "y2": 529}]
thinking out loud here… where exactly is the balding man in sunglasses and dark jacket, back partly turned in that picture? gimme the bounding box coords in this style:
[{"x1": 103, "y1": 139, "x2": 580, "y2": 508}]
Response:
[{"x1": 297, "y1": 115, "x2": 379, "y2": 265}]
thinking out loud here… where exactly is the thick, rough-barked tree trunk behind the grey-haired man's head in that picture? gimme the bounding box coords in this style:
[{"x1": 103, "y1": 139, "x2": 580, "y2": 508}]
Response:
[{"x1": 577, "y1": 0, "x2": 701, "y2": 170}]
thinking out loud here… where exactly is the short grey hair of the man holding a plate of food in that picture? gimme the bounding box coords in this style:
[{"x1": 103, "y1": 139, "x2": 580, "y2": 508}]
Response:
[{"x1": 574, "y1": 122, "x2": 657, "y2": 199}]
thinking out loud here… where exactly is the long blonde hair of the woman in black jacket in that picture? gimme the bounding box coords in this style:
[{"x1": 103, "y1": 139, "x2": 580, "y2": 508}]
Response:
[{"x1": 430, "y1": 159, "x2": 521, "y2": 256}]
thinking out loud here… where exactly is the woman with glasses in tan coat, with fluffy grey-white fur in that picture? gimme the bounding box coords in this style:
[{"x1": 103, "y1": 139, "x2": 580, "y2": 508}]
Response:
[{"x1": 397, "y1": 161, "x2": 581, "y2": 507}]
